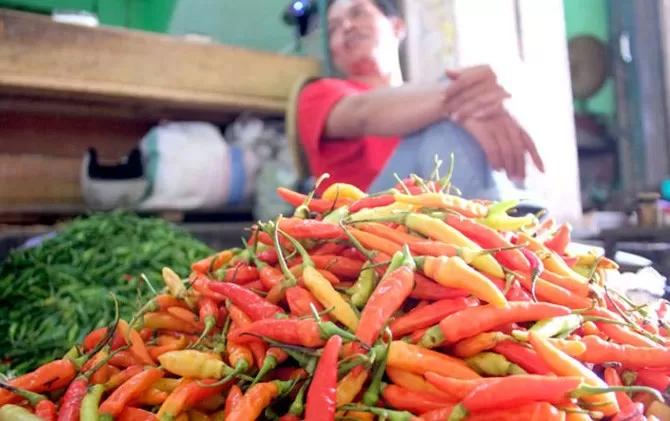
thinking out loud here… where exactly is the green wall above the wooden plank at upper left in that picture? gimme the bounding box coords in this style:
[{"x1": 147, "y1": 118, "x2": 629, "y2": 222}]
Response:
[{"x1": 0, "y1": 0, "x2": 293, "y2": 51}]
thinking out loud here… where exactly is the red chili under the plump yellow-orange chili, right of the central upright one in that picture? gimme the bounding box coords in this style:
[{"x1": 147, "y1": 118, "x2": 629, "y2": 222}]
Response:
[{"x1": 390, "y1": 297, "x2": 479, "y2": 338}]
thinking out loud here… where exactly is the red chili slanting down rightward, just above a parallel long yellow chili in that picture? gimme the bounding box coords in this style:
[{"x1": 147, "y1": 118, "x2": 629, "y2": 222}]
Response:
[{"x1": 444, "y1": 214, "x2": 530, "y2": 272}]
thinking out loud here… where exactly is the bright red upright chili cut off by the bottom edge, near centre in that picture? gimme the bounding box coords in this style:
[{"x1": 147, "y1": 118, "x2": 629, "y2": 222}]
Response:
[{"x1": 305, "y1": 335, "x2": 342, "y2": 421}]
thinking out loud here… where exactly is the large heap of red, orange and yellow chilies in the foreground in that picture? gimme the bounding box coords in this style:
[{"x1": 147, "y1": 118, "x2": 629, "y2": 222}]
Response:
[{"x1": 0, "y1": 171, "x2": 670, "y2": 421}]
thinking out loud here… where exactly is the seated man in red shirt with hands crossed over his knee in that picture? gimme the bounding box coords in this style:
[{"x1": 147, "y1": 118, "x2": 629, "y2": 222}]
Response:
[{"x1": 298, "y1": 0, "x2": 544, "y2": 199}]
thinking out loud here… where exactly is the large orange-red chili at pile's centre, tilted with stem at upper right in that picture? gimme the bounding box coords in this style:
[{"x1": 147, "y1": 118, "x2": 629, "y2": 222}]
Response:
[{"x1": 356, "y1": 255, "x2": 414, "y2": 345}]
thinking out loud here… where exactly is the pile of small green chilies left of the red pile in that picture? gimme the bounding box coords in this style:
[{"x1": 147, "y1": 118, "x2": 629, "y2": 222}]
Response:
[{"x1": 0, "y1": 212, "x2": 212, "y2": 374}]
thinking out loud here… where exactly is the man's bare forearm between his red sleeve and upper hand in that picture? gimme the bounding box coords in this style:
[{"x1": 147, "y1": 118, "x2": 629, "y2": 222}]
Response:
[{"x1": 325, "y1": 83, "x2": 452, "y2": 139}]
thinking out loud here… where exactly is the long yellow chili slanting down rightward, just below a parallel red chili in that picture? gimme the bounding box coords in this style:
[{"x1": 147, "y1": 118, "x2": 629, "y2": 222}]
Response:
[{"x1": 404, "y1": 213, "x2": 505, "y2": 278}]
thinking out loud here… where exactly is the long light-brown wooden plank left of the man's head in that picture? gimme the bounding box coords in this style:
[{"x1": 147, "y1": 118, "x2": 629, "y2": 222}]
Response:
[{"x1": 0, "y1": 9, "x2": 319, "y2": 114}]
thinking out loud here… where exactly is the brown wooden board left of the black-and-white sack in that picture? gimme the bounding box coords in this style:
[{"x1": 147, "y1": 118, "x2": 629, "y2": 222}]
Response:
[{"x1": 0, "y1": 154, "x2": 82, "y2": 206}]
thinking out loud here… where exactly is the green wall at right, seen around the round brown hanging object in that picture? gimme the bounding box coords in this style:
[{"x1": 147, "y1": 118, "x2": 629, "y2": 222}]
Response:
[{"x1": 563, "y1": 0, "x2": 616, "y2": 118}]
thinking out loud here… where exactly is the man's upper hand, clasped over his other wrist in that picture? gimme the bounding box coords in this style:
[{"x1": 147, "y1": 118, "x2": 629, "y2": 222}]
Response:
[{"x1": 444, "y1": 66, "x2": 510, "y2": 122}]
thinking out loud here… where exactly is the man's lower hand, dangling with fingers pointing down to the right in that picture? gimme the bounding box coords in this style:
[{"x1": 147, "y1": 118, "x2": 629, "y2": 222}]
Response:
[{"x1": 463, "y1": 111, "x2": 544, "y2": 180}]
